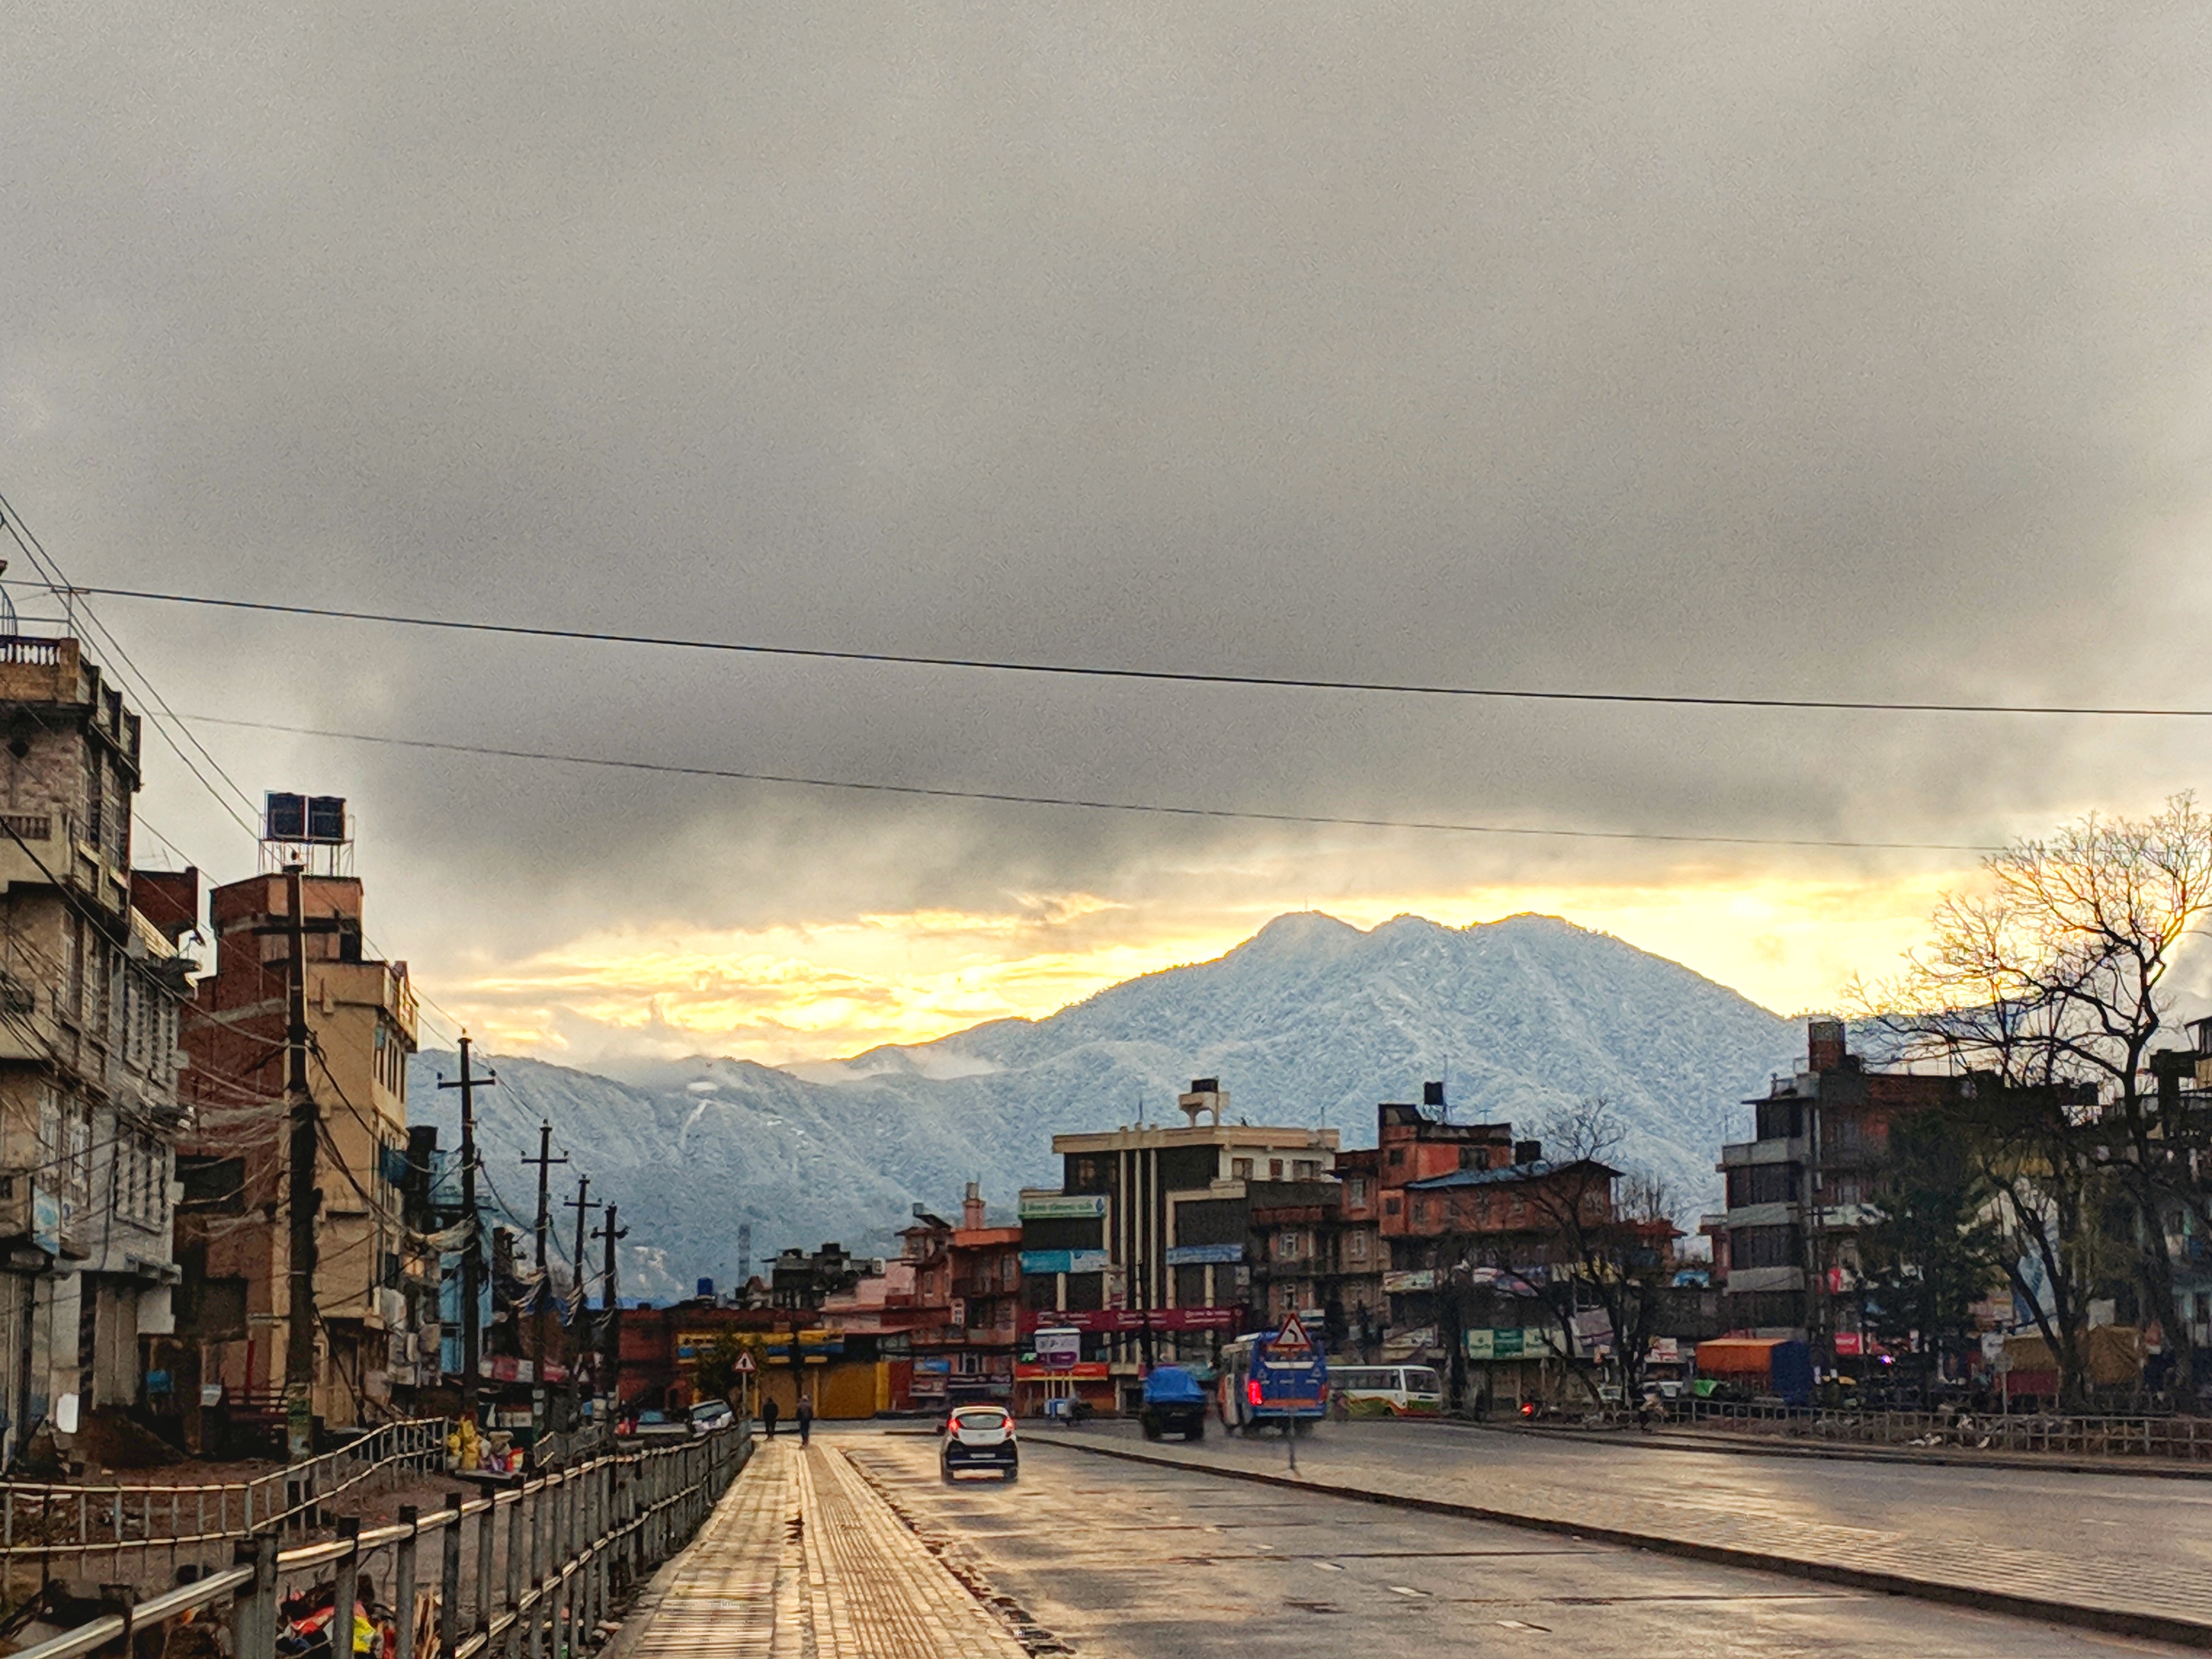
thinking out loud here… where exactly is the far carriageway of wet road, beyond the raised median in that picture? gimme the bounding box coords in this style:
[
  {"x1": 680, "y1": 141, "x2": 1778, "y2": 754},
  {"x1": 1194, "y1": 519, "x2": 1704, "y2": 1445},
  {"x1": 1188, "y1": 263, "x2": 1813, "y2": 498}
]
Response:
[{"x1": 1070, "y1": 1423, "x2": 2212, "y2": 1582}]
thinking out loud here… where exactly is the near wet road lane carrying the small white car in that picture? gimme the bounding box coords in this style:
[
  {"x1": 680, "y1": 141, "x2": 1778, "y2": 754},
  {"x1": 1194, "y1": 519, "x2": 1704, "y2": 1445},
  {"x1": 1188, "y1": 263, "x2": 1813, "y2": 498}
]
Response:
[{"x1": 825, "y1": 1425, "x2": 2179, "y2": 1659}]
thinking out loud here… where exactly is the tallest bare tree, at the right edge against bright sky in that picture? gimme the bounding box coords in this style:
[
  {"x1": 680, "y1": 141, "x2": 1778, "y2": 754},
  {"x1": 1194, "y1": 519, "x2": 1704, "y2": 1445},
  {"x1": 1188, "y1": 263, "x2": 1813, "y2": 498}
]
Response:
[{"x1": 1858, "y1": 794, "x2": 2212, "y2": 1404}]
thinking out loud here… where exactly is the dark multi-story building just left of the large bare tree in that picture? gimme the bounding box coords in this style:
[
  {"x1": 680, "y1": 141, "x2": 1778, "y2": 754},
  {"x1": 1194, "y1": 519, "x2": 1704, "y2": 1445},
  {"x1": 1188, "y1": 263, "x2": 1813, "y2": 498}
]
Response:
[{"x1": 1708, "y1": 1020, "x2": 1962, "y2": 1363}]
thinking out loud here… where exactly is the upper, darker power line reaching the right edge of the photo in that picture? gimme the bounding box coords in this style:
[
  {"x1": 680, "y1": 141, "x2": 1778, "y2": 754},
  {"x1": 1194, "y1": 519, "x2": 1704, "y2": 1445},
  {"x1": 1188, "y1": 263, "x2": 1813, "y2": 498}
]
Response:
[{"x1": 52, "y1": 589, "x2": 2212, "y2": 719}]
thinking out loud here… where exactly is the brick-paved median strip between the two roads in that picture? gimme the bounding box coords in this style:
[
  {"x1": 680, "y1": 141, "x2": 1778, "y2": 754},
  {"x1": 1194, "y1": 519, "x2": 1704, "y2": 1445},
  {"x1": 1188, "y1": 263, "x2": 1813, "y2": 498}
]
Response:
[{"x1": 1031, "y1": 1431, "x2": 2212, "y2": 1646}]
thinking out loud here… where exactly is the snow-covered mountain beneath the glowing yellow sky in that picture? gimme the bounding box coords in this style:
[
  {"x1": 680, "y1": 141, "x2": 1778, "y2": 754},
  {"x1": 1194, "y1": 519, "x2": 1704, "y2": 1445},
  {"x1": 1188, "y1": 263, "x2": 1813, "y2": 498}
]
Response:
[{"x1": 409, "y1": 913, "x2": 1803, "y2": 1294}]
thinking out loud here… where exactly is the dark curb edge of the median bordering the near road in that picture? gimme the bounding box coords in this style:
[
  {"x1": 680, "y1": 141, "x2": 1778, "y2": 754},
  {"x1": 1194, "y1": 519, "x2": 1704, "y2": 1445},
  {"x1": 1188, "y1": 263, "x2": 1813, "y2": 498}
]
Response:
[{"x1": 1031, "y1": 1440, "x2": 2212, "y2": 1648}]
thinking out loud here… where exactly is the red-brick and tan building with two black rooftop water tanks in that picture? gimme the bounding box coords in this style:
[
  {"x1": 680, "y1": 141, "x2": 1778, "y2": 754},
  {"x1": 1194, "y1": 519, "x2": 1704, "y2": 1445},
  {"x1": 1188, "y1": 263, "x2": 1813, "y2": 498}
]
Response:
[{"x1": 179, "y1": 797, "x2": 433, "y2": 1427}]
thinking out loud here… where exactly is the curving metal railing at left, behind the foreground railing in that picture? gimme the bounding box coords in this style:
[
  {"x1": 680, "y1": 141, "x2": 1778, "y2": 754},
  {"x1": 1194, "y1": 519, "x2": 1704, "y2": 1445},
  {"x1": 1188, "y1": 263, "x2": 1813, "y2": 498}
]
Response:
[{"x1": 0, "y1": 1418, "x2": 444, "y2": 1564}]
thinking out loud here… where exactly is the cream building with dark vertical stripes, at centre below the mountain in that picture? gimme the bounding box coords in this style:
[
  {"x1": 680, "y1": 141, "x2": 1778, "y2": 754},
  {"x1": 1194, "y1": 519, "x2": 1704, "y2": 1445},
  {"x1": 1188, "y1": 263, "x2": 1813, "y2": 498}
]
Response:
[{"x1": 1022, "y1": 1077, "x2": 1336, "y2": 1396}]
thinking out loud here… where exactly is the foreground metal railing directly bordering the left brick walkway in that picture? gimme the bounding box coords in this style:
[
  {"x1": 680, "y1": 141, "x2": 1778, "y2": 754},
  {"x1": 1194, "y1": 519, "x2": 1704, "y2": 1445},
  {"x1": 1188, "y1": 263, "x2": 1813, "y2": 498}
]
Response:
[{"x1": 15, "y1": 1429, "x2": 752, "y2": 1659}]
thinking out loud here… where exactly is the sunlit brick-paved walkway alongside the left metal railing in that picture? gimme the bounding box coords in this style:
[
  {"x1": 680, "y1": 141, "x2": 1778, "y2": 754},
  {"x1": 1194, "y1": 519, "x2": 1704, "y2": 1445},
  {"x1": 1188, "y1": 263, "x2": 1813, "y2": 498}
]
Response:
[{"x1": 622, "y1": 1438, "x2": 1024, "y2": 1659}]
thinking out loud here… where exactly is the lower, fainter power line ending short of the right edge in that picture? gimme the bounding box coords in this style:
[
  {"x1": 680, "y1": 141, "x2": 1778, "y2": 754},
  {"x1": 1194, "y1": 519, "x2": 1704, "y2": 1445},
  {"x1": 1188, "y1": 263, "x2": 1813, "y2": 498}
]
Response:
[{"x1": 186, "y1": 714, "x2": 1997, "y2": 854}]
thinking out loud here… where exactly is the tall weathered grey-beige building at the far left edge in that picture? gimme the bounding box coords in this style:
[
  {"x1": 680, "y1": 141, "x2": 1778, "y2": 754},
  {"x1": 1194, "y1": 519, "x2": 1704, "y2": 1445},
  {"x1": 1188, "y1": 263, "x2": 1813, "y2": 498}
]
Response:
[{"x1": 0, "y1": 633, "x2": 193, "y2": 1458}]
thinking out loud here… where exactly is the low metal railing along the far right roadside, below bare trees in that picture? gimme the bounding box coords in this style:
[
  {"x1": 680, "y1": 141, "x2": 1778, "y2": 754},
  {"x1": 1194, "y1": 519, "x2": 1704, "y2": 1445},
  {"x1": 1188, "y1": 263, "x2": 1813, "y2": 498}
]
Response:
[{"x1": 1683, "y1": 1400, "x2": 2212, "y2": 1462}]
